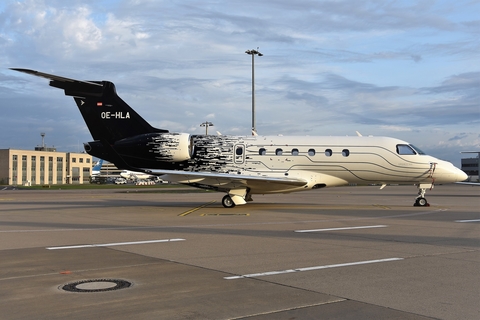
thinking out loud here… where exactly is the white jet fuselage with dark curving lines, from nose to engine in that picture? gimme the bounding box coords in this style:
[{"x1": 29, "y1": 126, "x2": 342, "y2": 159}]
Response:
[{"x1": 157, "y1": 135, "x2": 465, "y2": 194}]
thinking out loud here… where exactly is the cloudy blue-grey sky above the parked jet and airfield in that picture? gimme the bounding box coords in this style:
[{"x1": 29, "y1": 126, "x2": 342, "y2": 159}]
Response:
[{"x1": 0, "y1": 0, "x2": 480, "y2": 166}]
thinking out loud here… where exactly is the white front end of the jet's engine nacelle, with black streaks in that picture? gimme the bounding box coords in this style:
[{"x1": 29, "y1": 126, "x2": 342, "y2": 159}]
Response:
[{"x1": 152, "y1": 133, "x2": 193, "y2": 162}]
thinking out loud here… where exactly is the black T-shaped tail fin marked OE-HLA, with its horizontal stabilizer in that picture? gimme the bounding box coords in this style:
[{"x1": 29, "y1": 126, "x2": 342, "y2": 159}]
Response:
[{"x1": 12, "y1": 69, "x2": 168, "y2": 145}]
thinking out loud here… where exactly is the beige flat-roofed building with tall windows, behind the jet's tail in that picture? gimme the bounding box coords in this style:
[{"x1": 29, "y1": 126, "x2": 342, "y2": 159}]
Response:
[{"x1": 0, "y1": 148, "x2": 92, "y2": 185}]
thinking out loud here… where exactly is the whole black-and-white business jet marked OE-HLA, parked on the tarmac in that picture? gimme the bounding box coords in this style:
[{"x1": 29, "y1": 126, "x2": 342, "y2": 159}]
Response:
[{"x1": 12, "y1": 68, "x2": 467, "y2": 208}]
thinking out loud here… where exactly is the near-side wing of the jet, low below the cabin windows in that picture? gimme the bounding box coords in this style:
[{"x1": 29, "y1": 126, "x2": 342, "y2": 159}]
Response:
[{"x1": 143, "y1": 169, "x2": 308, "y2": 192}]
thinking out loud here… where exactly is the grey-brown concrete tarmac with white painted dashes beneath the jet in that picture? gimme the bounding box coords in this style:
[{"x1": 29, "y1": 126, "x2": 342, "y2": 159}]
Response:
[{"x1": 0, "y1": 185, "x2": 480, "y2": 320}]
